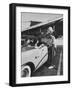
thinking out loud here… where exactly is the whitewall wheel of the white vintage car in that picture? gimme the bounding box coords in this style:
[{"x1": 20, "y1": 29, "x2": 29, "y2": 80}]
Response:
[{"x1": 21, "y1": 65, "x2": 31, "y2": 77}]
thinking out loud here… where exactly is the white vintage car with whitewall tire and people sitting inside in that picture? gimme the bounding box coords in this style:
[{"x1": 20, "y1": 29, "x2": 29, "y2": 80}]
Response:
[{"x1": 21, "y1": 38, "x2": 48, "y2": 77}]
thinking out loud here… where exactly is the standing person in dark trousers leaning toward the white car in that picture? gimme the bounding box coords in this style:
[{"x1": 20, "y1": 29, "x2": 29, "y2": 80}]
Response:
[{"x1": 41, "y1": 27, "x2": 55, "y2": 67}]
